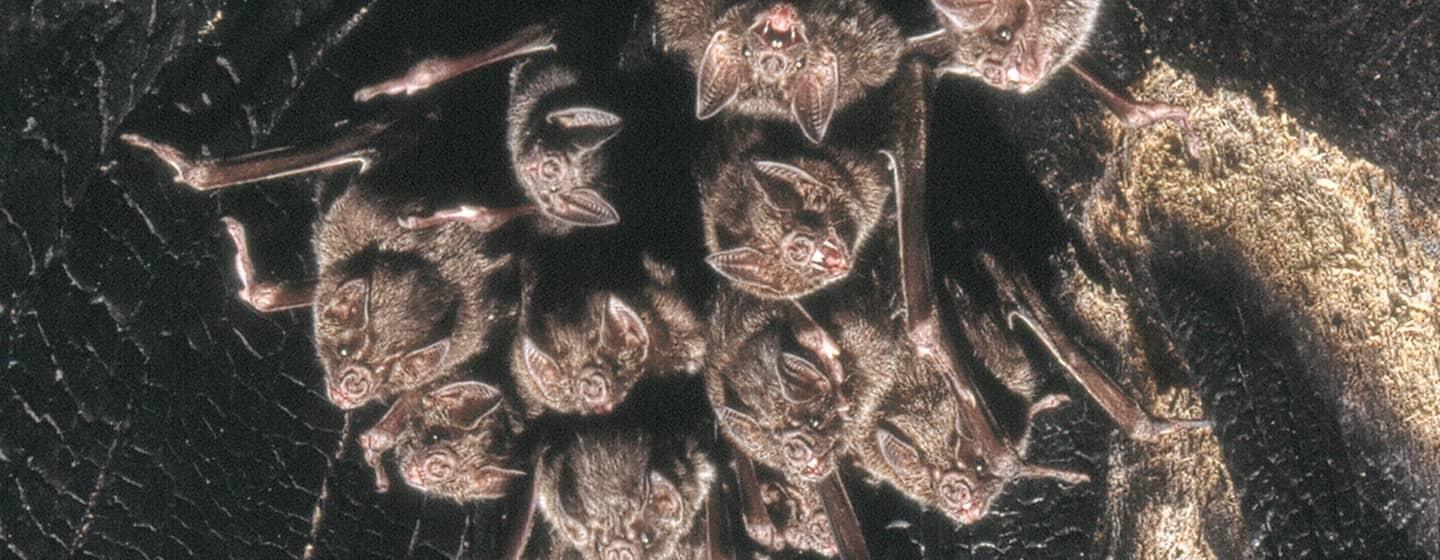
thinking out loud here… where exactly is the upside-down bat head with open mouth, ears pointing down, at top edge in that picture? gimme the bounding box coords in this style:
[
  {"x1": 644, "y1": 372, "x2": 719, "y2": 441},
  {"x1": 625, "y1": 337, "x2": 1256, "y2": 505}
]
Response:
[{"x1": 696, "y1": 3, "x2": 840, "y2": 143}]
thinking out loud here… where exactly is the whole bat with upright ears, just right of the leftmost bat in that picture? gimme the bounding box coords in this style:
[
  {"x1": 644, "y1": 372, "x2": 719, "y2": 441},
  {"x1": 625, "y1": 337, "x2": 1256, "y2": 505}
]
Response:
[{"x1": 511, "y1": 258, "x2": 706, "y2": 416}]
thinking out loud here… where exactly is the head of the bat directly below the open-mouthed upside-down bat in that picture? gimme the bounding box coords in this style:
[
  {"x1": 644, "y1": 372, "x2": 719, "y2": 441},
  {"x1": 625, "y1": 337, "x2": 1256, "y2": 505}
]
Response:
[{"x1": 706, "y1": 160, "x2": 860, "y2": 298}]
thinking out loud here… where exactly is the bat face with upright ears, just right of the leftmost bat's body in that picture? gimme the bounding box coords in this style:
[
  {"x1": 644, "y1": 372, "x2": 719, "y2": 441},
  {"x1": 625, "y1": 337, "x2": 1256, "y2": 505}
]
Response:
[{"x1": 511, "y1": 294, "x2": 651, "y2": 415}]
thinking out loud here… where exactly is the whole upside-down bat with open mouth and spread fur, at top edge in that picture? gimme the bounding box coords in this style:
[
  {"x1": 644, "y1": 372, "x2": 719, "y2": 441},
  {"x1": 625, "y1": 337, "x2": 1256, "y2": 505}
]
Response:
[{"x1": 655, "y1": 0, "x2": 904, "y2": 143}]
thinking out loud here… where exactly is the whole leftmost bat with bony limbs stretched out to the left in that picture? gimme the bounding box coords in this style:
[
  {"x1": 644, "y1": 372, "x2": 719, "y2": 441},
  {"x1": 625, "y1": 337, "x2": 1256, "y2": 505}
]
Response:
[{"x1": 121, "y1": 119, "x2": 516, "y2": 409}]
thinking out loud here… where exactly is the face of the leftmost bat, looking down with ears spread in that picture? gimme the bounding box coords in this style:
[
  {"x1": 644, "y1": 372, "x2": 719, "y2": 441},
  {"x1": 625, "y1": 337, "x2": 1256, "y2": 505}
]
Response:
[{"x1": 314, "y1": 265, "x2": 455, "y2": 410}]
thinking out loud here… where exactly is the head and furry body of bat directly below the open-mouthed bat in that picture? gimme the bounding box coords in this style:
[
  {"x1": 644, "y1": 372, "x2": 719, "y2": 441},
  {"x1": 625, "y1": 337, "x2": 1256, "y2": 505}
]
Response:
[{"x1": 706, "y1": 157, "x2": 887, "y2": 299}]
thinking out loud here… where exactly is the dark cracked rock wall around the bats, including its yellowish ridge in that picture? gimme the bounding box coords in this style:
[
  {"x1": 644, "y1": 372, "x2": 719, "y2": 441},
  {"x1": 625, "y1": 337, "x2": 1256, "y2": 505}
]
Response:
[{"x1": 0, "y1": 0, "x2": 1440, "y2": 559}]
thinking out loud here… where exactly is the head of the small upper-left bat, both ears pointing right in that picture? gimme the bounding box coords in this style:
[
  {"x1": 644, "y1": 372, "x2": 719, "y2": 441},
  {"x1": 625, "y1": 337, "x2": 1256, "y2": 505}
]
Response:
[{"x1": 507, "y1": 58, "x2": 622, "y2": 227}]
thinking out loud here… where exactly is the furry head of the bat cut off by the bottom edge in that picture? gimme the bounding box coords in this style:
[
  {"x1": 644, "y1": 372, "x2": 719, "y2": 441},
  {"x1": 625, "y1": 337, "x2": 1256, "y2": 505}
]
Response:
[{"x1": 539, "y1": 433, "x2": 714, "y2": 560}]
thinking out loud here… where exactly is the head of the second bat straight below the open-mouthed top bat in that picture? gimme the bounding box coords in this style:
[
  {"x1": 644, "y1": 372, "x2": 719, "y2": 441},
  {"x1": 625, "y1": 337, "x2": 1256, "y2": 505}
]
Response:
[{"x1": 716, "y1": 330, "x2": 845, "y2": 482}]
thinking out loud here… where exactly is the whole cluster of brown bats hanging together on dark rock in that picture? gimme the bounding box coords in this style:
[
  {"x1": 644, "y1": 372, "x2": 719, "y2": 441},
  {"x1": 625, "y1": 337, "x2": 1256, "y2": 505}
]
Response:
[{"x1": 122, "y1": 0, "x2": 1207, "y2": 560}]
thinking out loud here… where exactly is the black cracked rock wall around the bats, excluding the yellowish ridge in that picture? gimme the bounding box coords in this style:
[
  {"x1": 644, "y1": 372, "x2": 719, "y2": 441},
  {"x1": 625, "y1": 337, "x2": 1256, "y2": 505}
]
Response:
[{"x1": 0, "y1": 0, "x2": 1440, "y2": 559}]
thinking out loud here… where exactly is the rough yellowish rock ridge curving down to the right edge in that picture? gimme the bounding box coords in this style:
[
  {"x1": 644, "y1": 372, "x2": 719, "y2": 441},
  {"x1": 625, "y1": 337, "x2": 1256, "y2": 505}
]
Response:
[{"x1": 1070, "y1": 63, "x2": 1440, "y2": 556}]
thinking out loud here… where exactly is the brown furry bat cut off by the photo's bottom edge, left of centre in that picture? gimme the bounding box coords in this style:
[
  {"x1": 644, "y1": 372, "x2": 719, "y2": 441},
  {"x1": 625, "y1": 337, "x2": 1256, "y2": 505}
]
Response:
[{"x1": 536, "y1": 429, "x2": 719, "y2": 560}]
